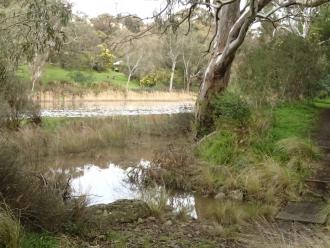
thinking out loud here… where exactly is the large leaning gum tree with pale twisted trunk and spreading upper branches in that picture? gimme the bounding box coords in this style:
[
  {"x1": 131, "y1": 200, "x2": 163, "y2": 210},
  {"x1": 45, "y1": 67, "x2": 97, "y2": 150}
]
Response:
[{"x1": 155, "y1": 0, "x2": 330, "y2": 135}]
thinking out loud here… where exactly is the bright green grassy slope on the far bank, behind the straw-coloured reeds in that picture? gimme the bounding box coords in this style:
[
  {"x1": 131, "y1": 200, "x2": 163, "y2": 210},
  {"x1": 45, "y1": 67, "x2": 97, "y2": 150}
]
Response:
[{"x1": 17, "y1": 65, "x2": 140, "y2": 89}]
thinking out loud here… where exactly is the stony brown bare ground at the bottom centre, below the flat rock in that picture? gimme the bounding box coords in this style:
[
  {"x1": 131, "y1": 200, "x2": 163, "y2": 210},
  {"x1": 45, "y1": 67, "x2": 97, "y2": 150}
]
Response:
[{"x1": 80, "y1": 216, "x2": 241, "y2": 248}]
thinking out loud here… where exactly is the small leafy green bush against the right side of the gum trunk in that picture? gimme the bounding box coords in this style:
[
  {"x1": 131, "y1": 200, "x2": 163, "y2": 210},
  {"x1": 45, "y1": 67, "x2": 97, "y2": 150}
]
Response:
[{"x1": 211, "y1": 92, "x2": 251, "y2": 126}]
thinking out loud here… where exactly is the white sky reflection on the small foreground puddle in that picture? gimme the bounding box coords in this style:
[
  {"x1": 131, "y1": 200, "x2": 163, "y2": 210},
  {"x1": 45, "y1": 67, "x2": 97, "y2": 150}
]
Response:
[{"x1": 72, "y1": 163, "x2": 198, "y2": 218}]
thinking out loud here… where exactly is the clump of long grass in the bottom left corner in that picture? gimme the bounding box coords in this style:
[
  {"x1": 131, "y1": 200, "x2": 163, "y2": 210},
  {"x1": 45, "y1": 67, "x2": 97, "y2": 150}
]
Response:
[{"x1": 0, "y1": 205, "x2": 22, "y2": 248}]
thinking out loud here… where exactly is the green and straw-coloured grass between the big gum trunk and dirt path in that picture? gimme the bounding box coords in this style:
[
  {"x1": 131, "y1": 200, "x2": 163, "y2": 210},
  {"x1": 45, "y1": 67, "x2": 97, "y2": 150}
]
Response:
[{"x1": 192, "y1": 98, "x2": 330, "y2": 224}]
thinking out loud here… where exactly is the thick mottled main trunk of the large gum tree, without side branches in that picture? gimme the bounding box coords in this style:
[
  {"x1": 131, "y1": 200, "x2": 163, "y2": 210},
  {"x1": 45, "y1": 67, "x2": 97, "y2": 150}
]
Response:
[{"x1": 195, "y1": 1, "x2": 240, "y2": 136}]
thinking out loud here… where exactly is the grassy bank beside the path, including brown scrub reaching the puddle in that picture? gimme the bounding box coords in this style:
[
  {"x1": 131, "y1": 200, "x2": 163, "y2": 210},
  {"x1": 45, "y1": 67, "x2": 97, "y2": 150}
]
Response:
[{"x1": 136, "y1": 96, "x2": 330, "y2": 226}]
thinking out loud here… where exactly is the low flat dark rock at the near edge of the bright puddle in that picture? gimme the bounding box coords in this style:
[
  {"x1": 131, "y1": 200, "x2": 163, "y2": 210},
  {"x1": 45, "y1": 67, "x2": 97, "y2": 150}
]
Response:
[{"x1": 86, "y1": 200, "x2": 151, "y2": 231}]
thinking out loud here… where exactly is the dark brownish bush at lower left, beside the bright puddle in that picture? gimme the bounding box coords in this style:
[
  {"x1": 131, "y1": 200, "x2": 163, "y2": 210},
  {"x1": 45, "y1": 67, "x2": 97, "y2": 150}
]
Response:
[{"x1": 0, "y1": 141, "x2": 87, "y2": 232}]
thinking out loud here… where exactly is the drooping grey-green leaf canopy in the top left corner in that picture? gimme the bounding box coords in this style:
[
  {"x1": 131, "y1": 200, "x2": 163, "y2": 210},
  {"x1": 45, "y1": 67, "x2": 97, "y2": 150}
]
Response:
[{"x1": 0, "y1": 0, "x2": 71, "y2": 65}]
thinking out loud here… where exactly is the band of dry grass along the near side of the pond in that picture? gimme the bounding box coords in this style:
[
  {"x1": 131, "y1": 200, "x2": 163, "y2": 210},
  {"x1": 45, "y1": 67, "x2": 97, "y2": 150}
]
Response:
[{"x1": 6, "y1": 115, "x2": 191, "y2": 165}]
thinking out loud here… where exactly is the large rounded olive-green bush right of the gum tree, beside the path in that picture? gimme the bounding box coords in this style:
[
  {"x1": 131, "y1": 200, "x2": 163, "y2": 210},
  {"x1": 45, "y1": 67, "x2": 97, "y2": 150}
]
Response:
[{"x1": 237, "y1": 34, "x2": 326, "y2": 104}]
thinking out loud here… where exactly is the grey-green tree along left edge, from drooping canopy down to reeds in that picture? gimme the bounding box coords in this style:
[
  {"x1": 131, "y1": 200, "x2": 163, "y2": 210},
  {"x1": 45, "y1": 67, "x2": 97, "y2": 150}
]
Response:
[{"x1": 0, "y1": 0, "x2": 71, "y2": 127}]
